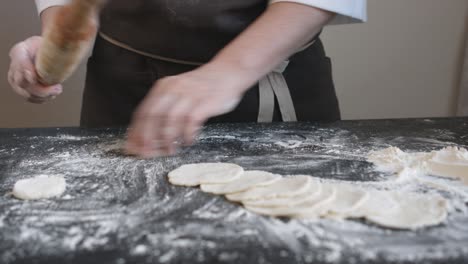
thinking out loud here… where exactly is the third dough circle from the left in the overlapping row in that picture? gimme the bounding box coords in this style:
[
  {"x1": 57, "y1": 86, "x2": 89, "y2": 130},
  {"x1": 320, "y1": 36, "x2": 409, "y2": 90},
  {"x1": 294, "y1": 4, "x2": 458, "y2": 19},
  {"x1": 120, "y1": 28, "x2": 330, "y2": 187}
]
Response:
[{"x1": 226, "y1": 175, "x2": 312, "y2": 202}]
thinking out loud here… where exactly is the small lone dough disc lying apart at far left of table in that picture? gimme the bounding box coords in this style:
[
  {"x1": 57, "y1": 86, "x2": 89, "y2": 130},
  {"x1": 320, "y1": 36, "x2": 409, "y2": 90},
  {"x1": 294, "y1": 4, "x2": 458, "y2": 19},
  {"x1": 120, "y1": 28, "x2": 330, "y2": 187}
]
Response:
[{"x1": 13, "y1": 175, "x2": 66, "y2": 200}]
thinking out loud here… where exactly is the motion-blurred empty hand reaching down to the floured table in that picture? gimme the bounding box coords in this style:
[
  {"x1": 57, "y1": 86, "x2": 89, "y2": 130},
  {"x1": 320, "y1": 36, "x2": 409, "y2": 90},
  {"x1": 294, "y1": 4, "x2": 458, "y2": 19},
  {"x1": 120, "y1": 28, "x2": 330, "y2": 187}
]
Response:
[{"x1": 126, "y1": 63, "x2": 247, "y2": 158}]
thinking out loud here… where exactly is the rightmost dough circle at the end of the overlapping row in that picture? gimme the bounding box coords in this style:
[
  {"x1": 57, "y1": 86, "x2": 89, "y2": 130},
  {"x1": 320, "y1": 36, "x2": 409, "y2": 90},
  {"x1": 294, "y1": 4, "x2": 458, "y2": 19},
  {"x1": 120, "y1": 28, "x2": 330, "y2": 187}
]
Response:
[{"x1": 366, "y1": 192, "x2": 448, "y2": 229}]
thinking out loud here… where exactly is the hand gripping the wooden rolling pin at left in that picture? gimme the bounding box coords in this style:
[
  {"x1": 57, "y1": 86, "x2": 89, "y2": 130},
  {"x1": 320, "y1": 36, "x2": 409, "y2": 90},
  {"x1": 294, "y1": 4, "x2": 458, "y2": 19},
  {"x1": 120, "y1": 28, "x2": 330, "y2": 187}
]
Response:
[{"x1": 8, "y1": 36, "x2": 62, "y2": 104}]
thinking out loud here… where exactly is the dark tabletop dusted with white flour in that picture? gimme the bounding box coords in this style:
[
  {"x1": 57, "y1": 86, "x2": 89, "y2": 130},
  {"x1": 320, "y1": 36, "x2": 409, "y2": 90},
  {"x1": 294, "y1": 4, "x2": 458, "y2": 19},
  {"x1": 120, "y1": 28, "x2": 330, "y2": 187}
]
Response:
[{"x1": 0, "y1": 118, "x2": 468, "y2": 264}]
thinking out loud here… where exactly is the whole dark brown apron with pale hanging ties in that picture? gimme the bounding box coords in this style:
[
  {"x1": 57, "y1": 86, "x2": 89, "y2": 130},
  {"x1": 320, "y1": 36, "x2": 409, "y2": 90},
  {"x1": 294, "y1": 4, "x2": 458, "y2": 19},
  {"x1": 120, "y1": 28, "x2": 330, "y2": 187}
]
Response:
[{"x1": 81, "y1": 0, "x2": 340, "y2": 127}]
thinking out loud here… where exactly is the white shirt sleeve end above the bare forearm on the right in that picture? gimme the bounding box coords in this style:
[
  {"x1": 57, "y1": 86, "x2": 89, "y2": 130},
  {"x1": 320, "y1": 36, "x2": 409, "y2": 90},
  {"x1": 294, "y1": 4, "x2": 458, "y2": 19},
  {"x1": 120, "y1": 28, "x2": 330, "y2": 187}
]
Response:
[{"x1": 270, "y1": 0, "x2": 367, "y2": 25}]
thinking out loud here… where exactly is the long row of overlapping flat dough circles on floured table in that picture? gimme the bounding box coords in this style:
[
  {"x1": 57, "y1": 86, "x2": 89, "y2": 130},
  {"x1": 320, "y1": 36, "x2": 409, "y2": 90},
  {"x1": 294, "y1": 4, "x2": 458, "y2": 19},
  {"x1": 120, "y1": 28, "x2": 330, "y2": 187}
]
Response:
[{"x1": 168, "y1": 163, "x2": 448, "y2": 229}]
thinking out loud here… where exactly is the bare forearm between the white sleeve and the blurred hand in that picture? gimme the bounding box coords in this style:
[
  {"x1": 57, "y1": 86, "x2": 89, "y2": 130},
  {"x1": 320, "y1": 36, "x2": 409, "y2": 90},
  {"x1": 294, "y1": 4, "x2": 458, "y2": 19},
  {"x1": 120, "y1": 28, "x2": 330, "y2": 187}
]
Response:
[{"x1": 206, "y1": 2, "x2": 334, "y2": 89}]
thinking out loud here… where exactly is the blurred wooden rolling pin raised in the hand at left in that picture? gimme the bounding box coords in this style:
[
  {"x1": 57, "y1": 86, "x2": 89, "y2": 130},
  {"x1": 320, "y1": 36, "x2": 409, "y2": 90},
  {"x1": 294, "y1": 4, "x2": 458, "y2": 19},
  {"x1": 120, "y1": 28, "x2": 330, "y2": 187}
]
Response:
[{"x1": 36, "y1": 0, "x2": 107, "y2": 85}]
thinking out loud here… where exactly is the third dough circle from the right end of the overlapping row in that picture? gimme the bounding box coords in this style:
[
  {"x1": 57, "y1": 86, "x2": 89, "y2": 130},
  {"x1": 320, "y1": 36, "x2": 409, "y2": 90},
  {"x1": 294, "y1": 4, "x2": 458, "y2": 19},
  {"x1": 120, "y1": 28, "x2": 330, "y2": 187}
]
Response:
[{"x1": 325, "y1": 183, "x2": 369, "y2": 218}]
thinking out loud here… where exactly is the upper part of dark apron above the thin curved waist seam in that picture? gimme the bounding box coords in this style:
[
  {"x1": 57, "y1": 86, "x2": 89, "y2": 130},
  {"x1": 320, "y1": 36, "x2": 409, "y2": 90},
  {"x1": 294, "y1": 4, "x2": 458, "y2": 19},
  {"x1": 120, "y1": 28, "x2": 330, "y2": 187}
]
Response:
[{"x1": 101, "y1": 0, "x2": 268, "y2": 62}]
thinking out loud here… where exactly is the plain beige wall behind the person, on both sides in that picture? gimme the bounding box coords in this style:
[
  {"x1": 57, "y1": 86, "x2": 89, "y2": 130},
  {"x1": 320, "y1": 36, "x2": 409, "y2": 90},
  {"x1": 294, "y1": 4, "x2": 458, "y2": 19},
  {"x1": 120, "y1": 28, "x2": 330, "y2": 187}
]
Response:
[{"x1": 0, "y1": 0, "x2": 468, "y2": 127}]
